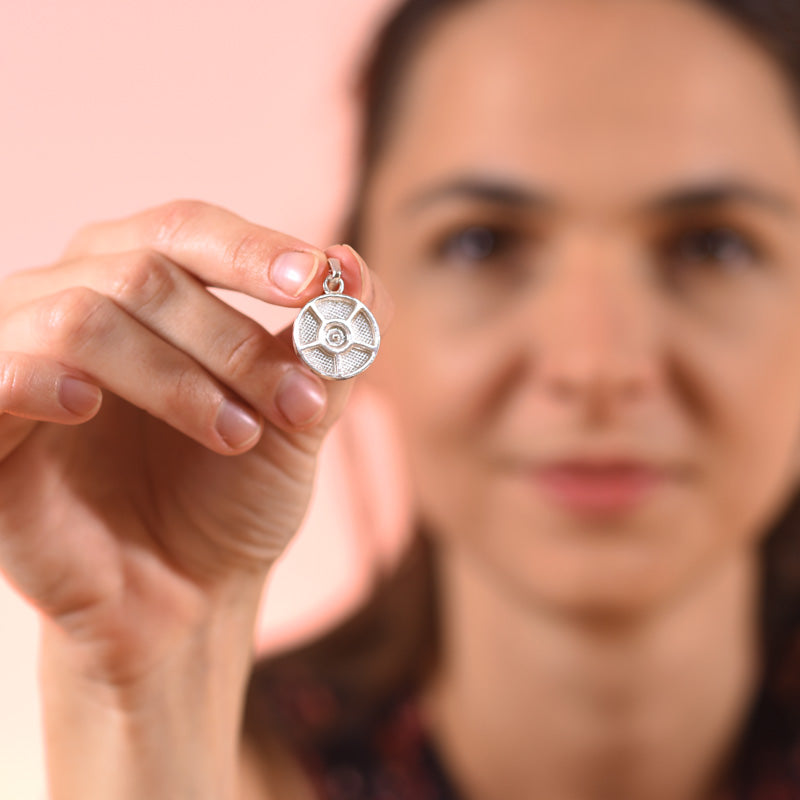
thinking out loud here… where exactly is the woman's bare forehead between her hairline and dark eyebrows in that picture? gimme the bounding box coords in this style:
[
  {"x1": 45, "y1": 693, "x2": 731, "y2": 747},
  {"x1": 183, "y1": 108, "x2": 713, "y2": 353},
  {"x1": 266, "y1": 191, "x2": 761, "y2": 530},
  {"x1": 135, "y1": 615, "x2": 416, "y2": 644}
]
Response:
[{"x1": 374, "y1": 0, "x2": 800, "y2": 216}]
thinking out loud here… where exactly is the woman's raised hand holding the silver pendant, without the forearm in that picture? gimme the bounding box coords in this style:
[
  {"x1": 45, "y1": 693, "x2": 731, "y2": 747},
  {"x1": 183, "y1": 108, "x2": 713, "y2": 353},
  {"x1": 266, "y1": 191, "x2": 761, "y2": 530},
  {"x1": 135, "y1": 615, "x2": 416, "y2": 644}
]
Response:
[{"x1": 0, "y1": 201, "x2": 388, "y2": 800}]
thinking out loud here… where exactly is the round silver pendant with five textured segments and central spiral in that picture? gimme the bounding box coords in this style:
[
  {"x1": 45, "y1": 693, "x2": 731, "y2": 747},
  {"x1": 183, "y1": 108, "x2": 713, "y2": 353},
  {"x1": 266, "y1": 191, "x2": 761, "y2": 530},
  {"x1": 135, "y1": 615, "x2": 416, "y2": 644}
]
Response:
[{"x1": 292, "y1": 258, "x2": 381, "y2": 381}]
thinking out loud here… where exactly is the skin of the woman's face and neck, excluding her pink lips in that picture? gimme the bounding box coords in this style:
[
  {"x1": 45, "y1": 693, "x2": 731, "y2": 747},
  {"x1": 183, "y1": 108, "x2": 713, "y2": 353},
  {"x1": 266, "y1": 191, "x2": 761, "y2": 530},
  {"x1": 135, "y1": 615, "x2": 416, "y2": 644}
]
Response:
[{"x1": 348, "y1": 0, "x2": 800, "y2": 800}]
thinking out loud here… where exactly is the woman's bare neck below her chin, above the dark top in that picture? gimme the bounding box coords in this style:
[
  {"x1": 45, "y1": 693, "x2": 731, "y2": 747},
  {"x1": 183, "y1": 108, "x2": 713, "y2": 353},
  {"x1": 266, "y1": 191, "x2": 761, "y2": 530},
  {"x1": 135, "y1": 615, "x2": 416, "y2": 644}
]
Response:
[{"x1": 423, "y1": 553, "x2": 760, "y2": 800}]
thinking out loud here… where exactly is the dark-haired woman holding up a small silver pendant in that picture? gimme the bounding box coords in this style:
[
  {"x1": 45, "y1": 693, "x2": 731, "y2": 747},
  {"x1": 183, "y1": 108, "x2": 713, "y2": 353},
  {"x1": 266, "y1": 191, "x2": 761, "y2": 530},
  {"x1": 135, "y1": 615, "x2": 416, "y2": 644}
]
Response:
[{"x1": 0, "y1": 0, "x2": 800, "y2": 800}]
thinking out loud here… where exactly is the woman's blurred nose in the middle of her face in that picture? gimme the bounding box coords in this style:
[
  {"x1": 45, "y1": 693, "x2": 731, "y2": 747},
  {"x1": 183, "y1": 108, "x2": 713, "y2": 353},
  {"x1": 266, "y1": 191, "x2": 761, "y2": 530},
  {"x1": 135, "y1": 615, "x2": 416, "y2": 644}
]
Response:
[{"x1": 532, "y1": 238, "x2": 663, "y2": 412}]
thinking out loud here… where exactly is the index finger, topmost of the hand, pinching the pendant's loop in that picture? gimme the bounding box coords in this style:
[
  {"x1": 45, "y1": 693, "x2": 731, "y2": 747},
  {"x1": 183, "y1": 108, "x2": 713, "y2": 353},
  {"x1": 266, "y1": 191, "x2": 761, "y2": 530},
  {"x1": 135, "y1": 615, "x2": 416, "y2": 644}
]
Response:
[{"x1": 59, "y1": 200, "x2": 340, "y2": 306}]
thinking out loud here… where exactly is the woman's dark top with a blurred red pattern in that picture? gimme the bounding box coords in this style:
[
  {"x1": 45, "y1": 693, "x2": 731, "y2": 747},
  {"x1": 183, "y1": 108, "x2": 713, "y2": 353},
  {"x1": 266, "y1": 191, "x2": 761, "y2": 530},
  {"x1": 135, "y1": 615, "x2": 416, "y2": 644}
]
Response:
[{"x1": 258, "y1": 671, "x2": 800, "y2": 800}]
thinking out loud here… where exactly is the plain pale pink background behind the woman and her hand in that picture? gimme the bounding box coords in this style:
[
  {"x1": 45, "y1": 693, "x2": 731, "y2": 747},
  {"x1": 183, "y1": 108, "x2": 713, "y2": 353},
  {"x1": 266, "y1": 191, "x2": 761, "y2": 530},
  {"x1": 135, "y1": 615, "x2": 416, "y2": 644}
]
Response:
[{"x1": 0, "y1": 0, "x2": 406, "y2": 800}]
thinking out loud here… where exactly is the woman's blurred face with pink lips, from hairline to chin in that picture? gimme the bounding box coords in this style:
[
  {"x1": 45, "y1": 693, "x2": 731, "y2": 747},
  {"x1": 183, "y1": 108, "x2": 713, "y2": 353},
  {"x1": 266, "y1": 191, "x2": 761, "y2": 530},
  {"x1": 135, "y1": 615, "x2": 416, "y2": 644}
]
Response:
[{"x1": 361, "y1": 0, "x2": 800, "y2": 613}]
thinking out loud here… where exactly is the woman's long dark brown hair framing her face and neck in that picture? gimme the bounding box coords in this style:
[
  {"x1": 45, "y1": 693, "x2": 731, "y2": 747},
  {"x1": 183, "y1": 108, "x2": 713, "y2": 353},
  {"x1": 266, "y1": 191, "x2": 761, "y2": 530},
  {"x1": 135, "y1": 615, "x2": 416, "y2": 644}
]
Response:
[{"x1": 245, "y1": 0, "x2": 800, "y2": 776}]
